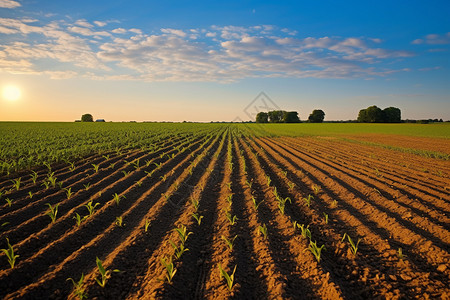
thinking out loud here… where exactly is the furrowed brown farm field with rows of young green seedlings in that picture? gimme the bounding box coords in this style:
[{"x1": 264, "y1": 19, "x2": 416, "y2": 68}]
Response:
[{"x1": 0, "y1": 123, "x2": 450, "y2": 299}]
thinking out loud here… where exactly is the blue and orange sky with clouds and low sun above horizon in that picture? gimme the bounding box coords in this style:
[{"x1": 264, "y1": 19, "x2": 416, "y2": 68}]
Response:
[{"x1": 0, "y1": 0, "x2": 450, "y2": 122}]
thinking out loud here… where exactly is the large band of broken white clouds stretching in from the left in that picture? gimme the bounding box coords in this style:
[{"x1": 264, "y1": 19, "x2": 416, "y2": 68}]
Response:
[{"x1": 0, "y1": 18, "x2": 414, "y2": 82}]
